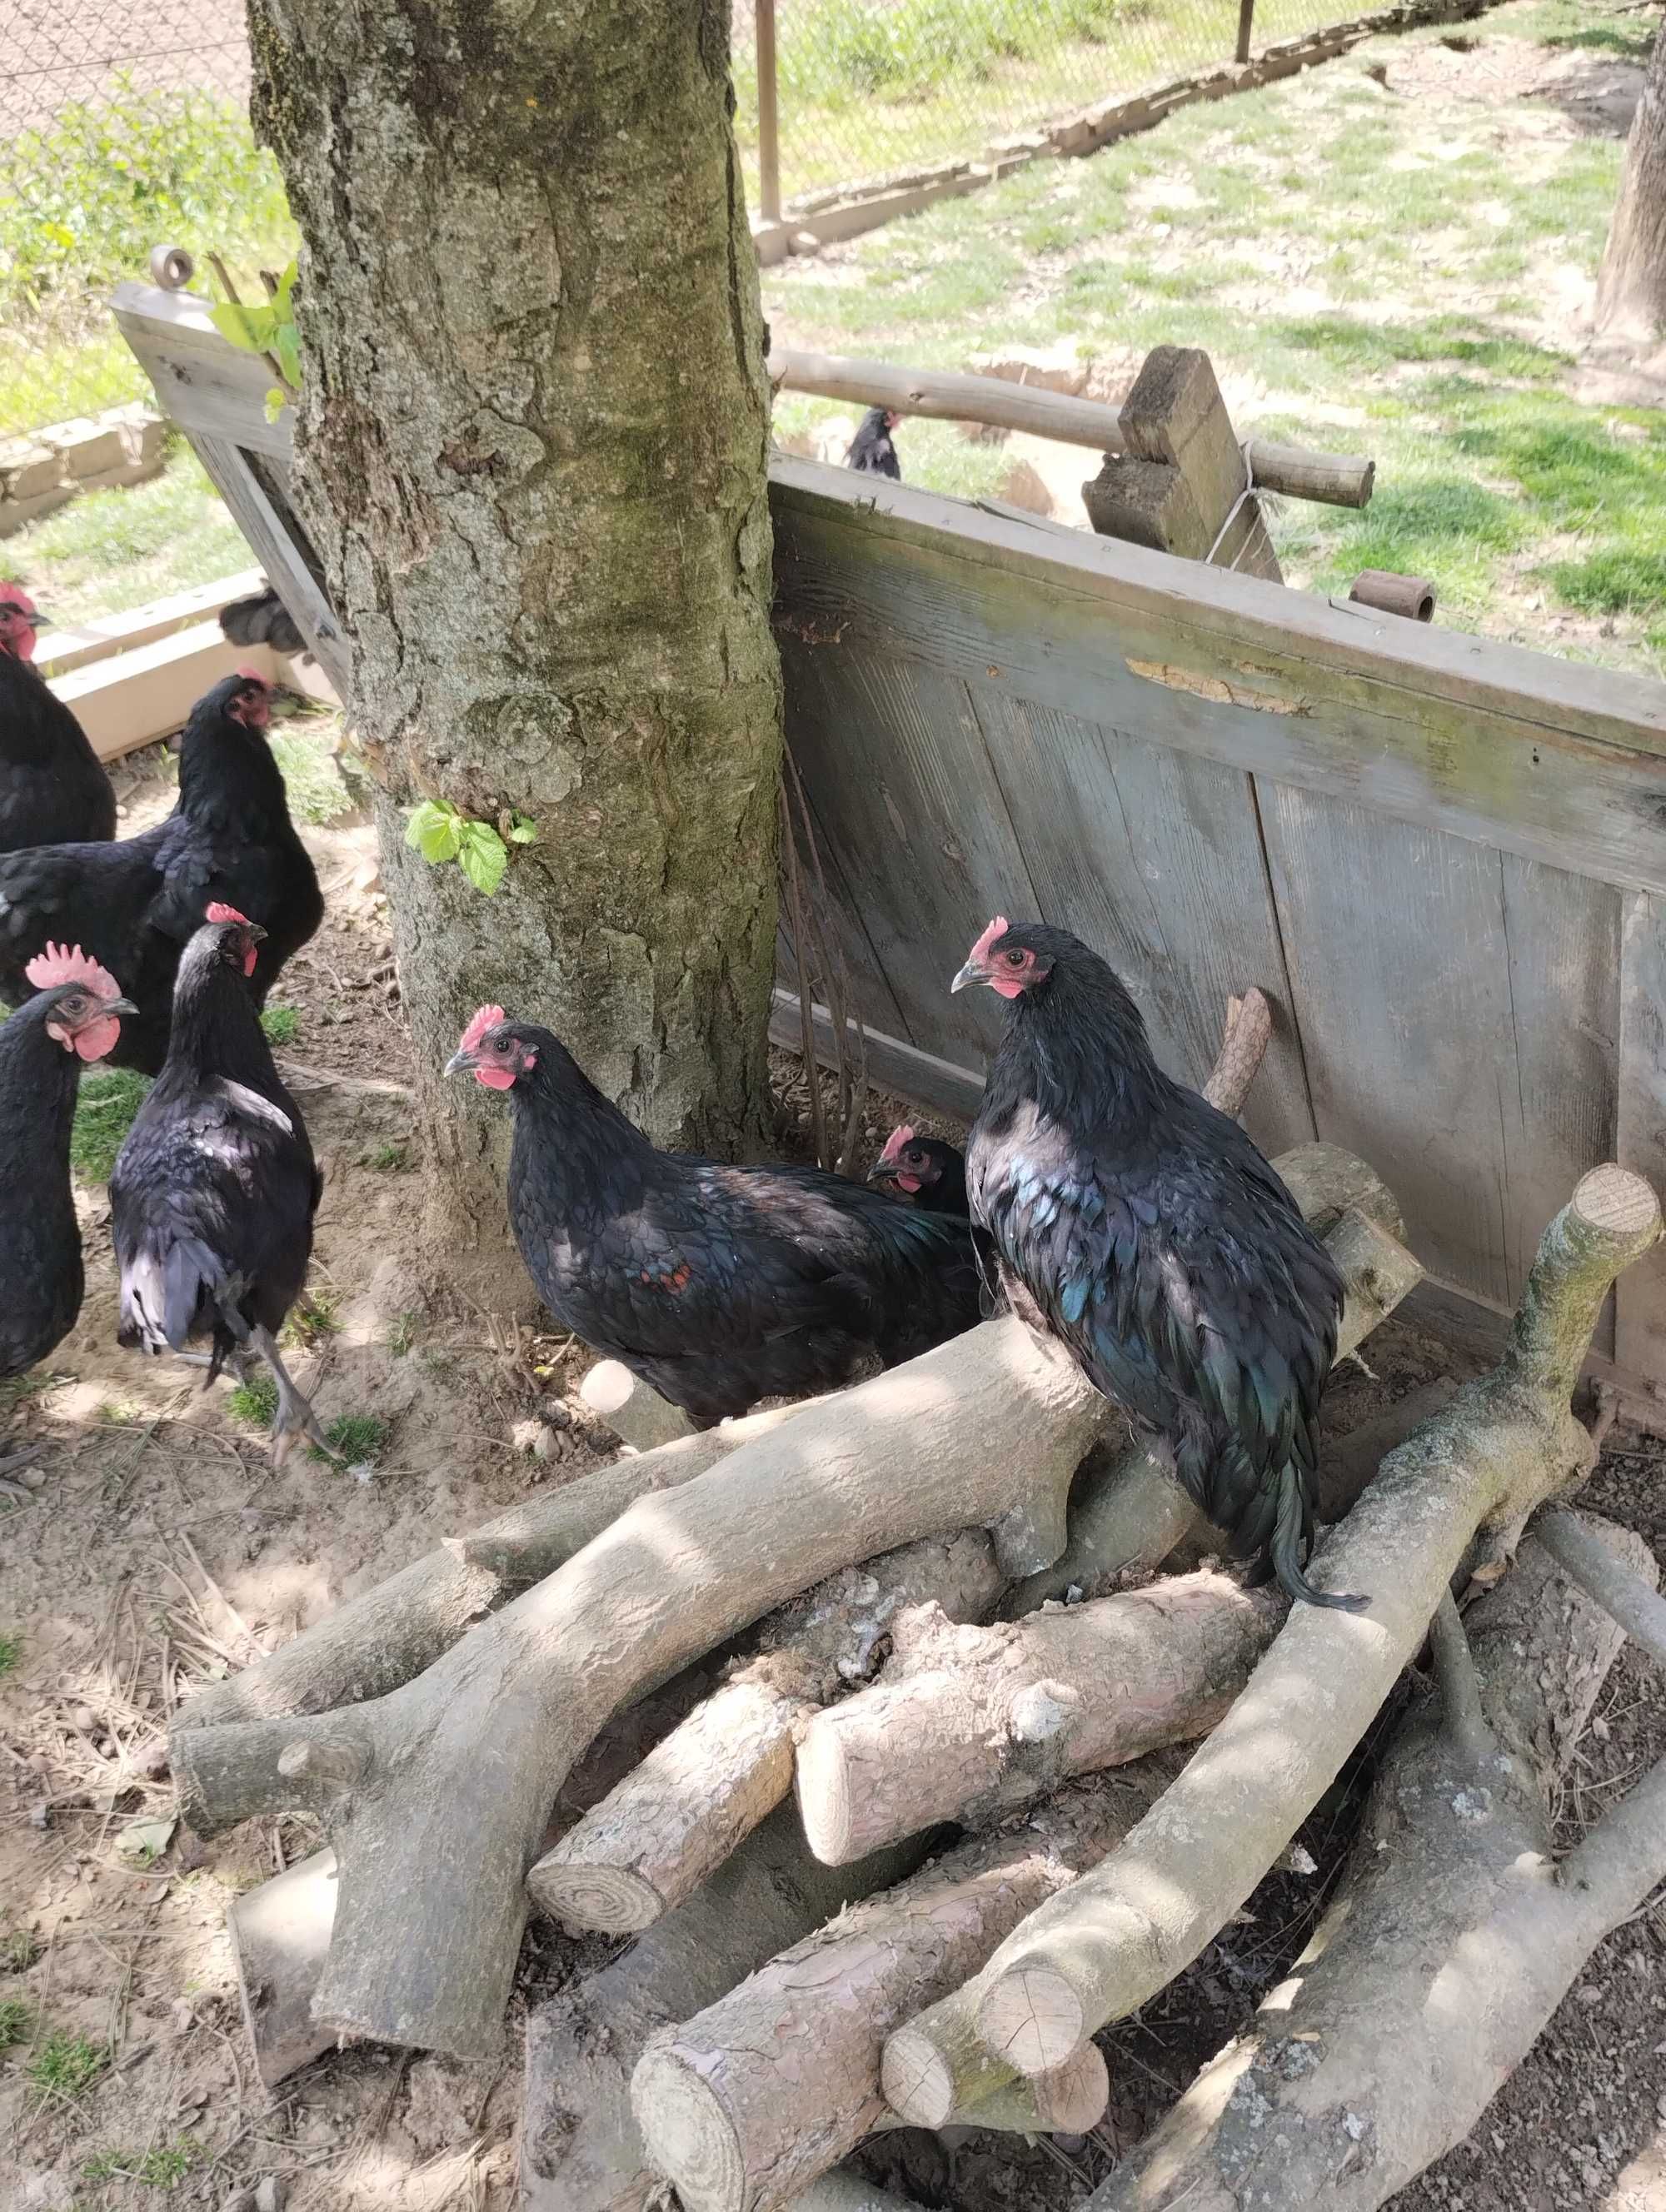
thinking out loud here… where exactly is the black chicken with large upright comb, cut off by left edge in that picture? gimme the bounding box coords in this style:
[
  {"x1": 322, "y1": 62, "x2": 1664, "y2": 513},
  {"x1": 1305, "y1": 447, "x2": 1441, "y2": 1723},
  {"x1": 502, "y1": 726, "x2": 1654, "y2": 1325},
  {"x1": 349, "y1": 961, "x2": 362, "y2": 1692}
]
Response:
[{"x1": 0, "y1": 944, "x2": 132, "y2": 1380}]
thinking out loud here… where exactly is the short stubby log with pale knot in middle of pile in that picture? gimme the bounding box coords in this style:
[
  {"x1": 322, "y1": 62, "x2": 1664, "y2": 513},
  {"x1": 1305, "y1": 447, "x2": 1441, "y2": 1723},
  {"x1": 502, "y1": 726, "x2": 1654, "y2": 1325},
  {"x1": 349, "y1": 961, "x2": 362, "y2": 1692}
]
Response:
[{"x1": 796, "y1": 1572, "x2": 1288, "y2": 1867}]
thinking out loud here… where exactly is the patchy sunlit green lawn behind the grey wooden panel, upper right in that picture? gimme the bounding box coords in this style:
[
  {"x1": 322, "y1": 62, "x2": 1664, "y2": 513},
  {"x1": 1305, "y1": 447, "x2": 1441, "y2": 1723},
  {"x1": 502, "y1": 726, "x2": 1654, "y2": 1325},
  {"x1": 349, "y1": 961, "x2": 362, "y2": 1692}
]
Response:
[{"x1": 763, "y1": 0, "x2": 1666, "y2": 675}]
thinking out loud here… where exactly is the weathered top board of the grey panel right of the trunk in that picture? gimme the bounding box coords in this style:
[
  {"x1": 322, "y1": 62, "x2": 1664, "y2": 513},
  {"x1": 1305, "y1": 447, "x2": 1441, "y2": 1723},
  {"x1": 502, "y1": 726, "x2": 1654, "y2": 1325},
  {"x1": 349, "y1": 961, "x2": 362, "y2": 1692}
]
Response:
[{"x1": 772, "y1": 456, "x2": 1666, "y2": 894}]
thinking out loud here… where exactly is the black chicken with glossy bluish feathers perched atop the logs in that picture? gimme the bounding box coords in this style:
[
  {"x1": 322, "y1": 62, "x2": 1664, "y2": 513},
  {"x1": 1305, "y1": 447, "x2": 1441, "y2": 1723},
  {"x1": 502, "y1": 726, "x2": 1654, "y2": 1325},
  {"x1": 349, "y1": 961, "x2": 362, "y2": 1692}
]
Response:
[{"x1": 954, "y1": 918, "x2": 1367, "y2": 1608}]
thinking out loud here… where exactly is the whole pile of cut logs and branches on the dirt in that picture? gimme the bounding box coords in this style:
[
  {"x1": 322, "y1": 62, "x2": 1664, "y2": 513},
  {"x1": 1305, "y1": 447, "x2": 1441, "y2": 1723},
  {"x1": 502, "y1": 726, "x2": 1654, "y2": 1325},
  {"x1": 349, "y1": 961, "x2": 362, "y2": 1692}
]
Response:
[{"x1": 171, "y1": 998, "x2": 1666, "y2": 2212}]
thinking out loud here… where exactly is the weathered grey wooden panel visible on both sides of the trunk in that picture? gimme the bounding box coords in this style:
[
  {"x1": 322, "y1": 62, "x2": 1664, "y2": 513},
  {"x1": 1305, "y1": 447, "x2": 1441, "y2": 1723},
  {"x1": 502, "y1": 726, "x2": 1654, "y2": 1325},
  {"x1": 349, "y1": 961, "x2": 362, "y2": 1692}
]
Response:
[{"x1": 115, "y1": 286, "x2": 1666, "y2": 1387}]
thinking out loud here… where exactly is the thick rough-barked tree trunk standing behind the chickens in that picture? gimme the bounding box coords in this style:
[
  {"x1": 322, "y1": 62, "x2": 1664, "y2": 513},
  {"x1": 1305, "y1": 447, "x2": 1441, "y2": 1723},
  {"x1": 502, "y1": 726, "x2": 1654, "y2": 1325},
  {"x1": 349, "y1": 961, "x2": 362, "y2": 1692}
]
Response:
[{"x1": 250, "y1": 0, "x2": 781, "y2": 1265}]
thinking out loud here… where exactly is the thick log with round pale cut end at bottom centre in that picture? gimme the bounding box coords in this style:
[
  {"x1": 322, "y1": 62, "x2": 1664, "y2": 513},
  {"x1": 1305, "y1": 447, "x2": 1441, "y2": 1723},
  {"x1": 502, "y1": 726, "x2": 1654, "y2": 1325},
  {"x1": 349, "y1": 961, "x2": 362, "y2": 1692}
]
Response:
[{"x1": 631, "y1": 1754, "x2": 1180, "y2": 2212}]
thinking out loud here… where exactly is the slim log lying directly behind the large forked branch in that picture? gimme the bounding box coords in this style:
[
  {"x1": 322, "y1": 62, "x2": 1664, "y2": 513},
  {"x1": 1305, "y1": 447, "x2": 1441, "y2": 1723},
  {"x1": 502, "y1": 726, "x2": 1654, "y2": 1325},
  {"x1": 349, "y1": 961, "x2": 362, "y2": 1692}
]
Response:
[{"x1": 172, "y1": 1407, "x2": 799, "y2": 1732}]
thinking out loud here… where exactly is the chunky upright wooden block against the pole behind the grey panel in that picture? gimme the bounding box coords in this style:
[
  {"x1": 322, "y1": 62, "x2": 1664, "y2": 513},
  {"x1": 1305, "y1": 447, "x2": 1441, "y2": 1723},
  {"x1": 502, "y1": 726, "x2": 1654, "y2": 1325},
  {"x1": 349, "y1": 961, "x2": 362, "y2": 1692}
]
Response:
[{"x1": 1082, "y1": 345, "x2": 1284, "y2": 584}]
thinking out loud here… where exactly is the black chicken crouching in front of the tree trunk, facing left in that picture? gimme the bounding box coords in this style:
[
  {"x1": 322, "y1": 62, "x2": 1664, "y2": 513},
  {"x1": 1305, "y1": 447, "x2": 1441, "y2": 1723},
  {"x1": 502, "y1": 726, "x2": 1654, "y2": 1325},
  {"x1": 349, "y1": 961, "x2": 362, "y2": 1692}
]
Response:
[{"x1": 447, "y1": 1006, "x2": 980, "y2": 1429}]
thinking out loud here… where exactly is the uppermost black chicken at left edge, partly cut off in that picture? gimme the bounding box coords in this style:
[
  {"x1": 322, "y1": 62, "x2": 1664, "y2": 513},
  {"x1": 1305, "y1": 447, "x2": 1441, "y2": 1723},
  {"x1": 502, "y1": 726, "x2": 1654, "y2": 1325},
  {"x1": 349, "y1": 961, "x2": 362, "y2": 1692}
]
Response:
[{"x1": 0, "y1": 584, "x2": 115, "y2": 854}]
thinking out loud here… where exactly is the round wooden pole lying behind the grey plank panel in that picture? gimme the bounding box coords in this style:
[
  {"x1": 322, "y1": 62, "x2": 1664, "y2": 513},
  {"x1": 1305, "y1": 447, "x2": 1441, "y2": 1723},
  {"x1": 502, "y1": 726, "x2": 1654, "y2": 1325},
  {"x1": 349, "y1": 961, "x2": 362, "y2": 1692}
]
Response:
[{"x1": 770, "y1": 345, "x2": 1376, "y2": 506}]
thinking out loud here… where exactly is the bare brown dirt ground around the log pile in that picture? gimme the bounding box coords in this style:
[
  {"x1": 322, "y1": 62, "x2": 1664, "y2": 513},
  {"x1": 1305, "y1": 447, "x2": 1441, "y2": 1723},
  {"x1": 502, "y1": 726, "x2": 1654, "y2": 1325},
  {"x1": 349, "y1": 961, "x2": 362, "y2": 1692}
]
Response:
[{"x1": 0, "y1": 734, "x2": 1666, "y2": 2212}]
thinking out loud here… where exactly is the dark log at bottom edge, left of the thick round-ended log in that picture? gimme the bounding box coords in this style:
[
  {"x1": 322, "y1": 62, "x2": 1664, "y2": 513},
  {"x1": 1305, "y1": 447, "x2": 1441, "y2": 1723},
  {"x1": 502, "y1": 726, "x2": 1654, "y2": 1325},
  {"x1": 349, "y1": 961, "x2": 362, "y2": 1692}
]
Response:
[{"x1": 520, "y1": 1810, "x2": 920, "y2": 2212}]
